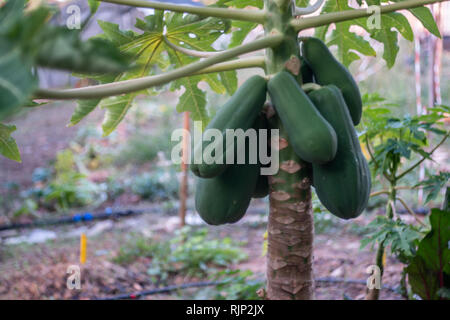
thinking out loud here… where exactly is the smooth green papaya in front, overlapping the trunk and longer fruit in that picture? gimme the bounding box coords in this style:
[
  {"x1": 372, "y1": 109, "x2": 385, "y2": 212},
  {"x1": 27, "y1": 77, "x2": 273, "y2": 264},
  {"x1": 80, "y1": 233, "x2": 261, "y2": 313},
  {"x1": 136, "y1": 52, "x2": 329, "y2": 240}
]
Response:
[{"x1": 267, "y1": 71, "x2": 337, "y2": 163}]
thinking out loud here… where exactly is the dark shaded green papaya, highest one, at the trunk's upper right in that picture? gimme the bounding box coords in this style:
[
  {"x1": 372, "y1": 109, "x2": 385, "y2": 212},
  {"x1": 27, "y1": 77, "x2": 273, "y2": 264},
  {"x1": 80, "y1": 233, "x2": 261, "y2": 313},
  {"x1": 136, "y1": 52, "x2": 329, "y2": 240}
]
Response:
[{"x1": 301, "y1": 38, "x2": 362, "y2": 126}]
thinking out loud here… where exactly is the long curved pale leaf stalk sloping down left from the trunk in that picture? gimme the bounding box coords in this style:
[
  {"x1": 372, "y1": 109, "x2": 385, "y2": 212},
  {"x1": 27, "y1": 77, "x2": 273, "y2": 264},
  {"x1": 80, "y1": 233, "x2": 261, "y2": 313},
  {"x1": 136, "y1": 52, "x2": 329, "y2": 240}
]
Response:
[{"x1": 34, "y1": 35, "x2": 284, "y2": 100}]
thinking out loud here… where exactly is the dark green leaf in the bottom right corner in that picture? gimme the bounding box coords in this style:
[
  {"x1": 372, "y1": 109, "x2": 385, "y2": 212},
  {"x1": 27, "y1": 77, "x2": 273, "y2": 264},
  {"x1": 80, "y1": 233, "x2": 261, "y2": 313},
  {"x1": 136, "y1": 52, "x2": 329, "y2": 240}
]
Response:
[{"x1": 406, "y1": 209, "x2": 450, "y2": 300}]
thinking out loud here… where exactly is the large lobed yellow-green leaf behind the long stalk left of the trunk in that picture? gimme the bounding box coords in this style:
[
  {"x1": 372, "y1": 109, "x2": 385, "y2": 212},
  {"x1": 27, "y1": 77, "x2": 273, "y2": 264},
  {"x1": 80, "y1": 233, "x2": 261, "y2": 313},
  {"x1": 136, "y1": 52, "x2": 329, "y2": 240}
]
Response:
[{"x1": 71, "y1": 10, "x2": 243, "y2": 135}]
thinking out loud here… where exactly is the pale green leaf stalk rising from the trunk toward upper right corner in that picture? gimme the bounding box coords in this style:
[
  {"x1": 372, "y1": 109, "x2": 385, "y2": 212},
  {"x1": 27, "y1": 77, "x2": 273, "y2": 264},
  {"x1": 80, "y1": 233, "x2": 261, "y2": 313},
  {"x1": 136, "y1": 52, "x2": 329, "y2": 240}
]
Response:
[{"x1": 291, "y1": 0, "x2": 448, "y2": 31}]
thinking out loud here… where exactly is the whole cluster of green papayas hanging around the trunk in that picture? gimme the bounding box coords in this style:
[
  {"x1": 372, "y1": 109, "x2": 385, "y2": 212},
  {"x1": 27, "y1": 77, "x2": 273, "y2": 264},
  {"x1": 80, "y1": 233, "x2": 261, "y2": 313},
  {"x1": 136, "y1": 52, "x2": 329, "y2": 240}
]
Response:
[{"x1": 191, "y1": 37, "x2": 371, "y2": 225}]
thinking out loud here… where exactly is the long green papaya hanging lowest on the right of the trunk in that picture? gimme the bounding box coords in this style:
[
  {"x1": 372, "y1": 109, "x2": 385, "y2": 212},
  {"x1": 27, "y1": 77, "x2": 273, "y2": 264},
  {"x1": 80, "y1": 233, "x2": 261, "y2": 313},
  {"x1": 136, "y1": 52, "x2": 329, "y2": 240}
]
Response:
[{"x1": 309, "y1": 85, "x2": 371, "y2": 219}]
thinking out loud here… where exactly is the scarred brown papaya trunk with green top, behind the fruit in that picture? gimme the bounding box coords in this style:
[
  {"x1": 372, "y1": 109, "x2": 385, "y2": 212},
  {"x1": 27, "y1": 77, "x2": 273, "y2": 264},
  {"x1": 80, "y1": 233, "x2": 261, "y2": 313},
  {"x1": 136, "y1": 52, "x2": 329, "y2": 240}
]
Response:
[{"x1": 265, "y1": 0, "x2": 314, "y2": 300}]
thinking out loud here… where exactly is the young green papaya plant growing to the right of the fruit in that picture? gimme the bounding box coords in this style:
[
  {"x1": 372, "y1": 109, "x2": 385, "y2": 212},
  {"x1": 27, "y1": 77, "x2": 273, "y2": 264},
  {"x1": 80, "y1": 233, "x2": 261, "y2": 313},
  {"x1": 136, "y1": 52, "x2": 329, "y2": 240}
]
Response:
[{"x1": 360, "y1": 95, "x2": 450, "y2": 299}]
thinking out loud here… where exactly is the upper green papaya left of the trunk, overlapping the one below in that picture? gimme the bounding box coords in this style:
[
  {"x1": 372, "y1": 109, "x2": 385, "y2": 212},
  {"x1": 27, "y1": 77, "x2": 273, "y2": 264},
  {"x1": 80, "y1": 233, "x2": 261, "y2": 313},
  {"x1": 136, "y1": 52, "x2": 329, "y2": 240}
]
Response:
[{"x1": 190, "y1": 76, "x2": 267, "y2": 178}]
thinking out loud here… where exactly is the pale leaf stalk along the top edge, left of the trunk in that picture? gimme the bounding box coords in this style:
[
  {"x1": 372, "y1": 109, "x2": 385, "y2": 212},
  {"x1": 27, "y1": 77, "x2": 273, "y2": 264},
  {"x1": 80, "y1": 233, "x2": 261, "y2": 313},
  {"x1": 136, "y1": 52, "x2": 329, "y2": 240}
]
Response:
[{"x1": 98, "y1": 0, "x2": 266, "y2": 23}]
